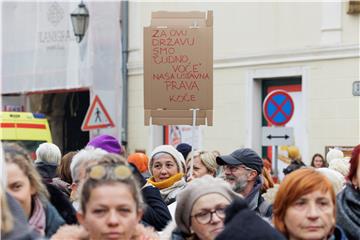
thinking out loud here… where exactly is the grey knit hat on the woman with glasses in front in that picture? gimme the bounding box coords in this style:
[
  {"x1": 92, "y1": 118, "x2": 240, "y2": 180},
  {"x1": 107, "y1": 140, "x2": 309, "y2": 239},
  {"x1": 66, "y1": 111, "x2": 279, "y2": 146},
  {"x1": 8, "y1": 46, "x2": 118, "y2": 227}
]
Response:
[{"x1": 175, "y1": 175, "x2": 241, "y2": 234}]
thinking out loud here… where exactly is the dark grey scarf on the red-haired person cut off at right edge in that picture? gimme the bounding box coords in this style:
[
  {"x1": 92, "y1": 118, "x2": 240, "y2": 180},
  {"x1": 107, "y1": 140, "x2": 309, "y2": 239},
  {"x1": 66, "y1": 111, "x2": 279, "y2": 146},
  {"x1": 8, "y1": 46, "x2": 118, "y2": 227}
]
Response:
[{"x1": 336, "y1": 183, "x2": 360, "y2": 239}]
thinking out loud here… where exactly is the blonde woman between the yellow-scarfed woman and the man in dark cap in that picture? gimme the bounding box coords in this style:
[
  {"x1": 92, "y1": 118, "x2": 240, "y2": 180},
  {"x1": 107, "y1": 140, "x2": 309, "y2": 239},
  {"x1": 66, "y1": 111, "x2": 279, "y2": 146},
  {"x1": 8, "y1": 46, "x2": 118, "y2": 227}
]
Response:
[{"x1": 186, "y1": 151, "x2": 218, "y2": 182}]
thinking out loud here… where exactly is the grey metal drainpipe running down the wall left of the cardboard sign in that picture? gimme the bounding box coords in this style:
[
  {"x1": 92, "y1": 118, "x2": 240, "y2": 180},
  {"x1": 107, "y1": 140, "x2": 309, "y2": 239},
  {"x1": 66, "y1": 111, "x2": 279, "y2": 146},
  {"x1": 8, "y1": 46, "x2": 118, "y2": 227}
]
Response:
[{"x1": 120, "y1": 1, "x2": 129, "y2": 146}]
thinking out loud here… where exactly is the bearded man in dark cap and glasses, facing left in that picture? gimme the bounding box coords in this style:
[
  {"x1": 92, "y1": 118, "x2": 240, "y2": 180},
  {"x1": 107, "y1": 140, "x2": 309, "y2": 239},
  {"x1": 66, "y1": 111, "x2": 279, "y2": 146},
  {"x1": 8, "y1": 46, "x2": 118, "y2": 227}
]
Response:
[{"x1": 216, "y1": 148, "x2": 272, "y2": 217}]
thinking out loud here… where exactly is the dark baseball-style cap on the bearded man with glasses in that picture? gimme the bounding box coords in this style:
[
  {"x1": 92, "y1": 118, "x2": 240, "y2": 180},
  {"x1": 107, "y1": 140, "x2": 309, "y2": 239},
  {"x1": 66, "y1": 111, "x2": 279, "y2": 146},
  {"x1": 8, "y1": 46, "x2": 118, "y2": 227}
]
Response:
[{"x1": 216, "y1": 148, "x2": 264, "y2": 174}]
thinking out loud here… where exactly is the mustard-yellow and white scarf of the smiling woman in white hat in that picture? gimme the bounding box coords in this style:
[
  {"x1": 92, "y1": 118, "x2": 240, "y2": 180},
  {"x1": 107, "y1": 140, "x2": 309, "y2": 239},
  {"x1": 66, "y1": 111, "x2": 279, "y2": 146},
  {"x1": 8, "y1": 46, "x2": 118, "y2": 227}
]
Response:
[{"x1": 148, "y1": 173, "x2": 186, "y2": 205}]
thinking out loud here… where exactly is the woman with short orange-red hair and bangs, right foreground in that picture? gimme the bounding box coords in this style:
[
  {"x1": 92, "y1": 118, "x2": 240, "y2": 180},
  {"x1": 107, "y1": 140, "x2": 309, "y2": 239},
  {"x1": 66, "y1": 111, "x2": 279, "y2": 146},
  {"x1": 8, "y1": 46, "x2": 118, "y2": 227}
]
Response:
[{"x1": 273, "y1": 168, "x2": 348, "y2": 240}]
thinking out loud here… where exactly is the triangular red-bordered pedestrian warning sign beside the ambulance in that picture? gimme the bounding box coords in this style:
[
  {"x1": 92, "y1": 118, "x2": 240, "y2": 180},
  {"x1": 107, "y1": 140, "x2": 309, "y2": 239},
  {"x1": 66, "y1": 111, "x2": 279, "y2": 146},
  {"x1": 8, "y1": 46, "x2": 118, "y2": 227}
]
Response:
[{"x1": 81, "y1": 95, "x2": 115, "y2": 131}]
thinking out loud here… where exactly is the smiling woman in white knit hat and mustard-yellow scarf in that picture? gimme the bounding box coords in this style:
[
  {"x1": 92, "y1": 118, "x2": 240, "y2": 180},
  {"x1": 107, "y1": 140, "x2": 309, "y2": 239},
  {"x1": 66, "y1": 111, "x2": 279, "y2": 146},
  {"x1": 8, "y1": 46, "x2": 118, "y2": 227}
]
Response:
[{"x1": 148, "y1": 145, "x2": 186, "y2": 217}]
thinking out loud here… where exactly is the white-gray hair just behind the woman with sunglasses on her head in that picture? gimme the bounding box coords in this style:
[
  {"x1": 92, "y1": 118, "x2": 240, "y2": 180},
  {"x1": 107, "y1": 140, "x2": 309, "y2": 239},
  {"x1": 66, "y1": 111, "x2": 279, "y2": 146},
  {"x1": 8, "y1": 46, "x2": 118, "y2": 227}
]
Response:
[{"x1": 70, "y1": 148, "x2": 107, "y2": 182}]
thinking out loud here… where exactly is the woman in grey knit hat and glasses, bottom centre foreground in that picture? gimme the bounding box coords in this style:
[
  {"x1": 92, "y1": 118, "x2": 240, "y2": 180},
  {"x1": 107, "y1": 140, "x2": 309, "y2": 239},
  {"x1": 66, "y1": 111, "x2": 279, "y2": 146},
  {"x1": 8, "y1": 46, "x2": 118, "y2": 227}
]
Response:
[{"x1": 161, "y1": 175, "x2": 240, "y2": 240}]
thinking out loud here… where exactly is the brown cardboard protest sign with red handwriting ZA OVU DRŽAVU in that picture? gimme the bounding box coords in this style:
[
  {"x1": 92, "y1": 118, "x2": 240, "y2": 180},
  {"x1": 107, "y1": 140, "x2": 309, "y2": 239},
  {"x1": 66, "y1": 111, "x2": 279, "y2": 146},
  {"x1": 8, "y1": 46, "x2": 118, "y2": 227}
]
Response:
[{"x1": 144, "y1": 11, "x2": 213, "y2": 125}]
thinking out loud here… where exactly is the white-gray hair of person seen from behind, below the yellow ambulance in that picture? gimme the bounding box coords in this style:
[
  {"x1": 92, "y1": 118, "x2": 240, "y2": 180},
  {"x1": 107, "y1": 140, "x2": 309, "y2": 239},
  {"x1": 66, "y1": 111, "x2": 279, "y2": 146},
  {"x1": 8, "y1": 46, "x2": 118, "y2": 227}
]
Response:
[{"x1": 36, "y1": 143, "x2": 61, "y2": 166}]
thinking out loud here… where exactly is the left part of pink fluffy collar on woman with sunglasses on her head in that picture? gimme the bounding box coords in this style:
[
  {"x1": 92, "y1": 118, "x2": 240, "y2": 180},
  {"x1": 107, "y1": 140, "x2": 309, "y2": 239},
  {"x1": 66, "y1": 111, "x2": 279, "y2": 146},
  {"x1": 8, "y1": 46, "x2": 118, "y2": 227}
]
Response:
[{"x1": 50, "y1": 225, "x2": 89, "y2": 240}]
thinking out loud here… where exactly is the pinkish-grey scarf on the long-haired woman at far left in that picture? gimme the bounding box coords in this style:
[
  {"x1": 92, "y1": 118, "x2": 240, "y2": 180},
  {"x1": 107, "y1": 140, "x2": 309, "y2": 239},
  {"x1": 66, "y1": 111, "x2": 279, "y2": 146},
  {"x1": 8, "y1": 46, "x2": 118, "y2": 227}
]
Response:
[{"x1": 29, "y1": 196, "x2": 46, "y2": 236}]
